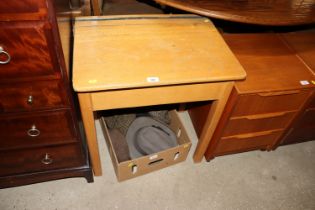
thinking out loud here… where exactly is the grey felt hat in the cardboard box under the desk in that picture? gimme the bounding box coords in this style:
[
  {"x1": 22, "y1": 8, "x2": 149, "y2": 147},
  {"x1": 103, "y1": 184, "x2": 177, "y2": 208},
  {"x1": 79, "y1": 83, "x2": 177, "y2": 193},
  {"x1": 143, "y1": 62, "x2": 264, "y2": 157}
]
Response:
[{"x1": 126, "y1": 116, "x2": 178, "y2": 159}]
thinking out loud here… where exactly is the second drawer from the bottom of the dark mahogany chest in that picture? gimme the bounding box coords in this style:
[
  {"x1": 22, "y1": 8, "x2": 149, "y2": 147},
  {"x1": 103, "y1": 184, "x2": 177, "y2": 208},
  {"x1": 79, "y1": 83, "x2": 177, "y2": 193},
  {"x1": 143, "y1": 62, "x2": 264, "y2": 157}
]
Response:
[{"x1": 0, "y1": 110, "x2": 76, "y2": 150}]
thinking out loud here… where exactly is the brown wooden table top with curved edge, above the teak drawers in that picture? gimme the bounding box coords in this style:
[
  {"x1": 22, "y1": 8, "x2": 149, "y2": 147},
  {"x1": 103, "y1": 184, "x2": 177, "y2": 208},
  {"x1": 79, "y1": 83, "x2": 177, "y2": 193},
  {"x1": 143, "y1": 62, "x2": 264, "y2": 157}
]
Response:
[{"x1": 155, "y1": 0, "x2": 315, "y2": 26}]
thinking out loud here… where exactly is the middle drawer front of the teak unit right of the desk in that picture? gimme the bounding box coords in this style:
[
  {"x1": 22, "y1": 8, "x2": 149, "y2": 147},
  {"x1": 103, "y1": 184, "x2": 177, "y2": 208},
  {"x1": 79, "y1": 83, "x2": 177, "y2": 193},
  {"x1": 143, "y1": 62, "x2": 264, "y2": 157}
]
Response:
[{"x1": 223, "y1": 112, "x2": 296, "y2": 137}]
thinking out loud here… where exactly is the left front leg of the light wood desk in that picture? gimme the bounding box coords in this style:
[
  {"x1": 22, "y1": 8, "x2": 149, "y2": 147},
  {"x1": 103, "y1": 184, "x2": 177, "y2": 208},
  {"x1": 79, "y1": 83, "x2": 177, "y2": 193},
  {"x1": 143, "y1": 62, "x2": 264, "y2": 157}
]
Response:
[{"x1": 78, "y1": 93, "x2": 102, "y2": 176}]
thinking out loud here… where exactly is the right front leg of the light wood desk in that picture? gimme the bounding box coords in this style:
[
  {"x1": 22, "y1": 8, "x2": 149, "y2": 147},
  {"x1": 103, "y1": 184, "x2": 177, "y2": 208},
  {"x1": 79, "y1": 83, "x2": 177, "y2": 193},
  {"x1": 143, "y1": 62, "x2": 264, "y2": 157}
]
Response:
[{"x1": 193, "y1": 82, "x2": 234, "y2": 163}]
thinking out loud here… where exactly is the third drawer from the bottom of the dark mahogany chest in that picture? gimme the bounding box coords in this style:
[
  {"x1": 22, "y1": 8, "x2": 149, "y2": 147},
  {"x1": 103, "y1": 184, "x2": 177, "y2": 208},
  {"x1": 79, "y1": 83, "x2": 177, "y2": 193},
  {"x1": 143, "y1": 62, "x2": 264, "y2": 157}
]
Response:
[{"x1": 0, "y1": 80, "x2": 69, "y2": 113}]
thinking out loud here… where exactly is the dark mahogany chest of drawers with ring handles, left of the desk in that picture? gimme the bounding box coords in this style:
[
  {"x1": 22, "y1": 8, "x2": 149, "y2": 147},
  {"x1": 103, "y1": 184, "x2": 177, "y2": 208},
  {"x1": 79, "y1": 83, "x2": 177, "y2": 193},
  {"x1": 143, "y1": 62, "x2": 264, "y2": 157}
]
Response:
[{"x1": 0, "y1": 0, "x2": 93, "y2": 188}]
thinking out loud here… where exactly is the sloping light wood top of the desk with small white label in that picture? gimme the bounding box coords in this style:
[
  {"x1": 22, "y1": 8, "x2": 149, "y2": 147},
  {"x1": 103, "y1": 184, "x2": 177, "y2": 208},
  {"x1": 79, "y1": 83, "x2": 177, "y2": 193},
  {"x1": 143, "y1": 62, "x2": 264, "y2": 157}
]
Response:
[{"x1": 73, "y1": 15, "x2": 245, "y2": 92}]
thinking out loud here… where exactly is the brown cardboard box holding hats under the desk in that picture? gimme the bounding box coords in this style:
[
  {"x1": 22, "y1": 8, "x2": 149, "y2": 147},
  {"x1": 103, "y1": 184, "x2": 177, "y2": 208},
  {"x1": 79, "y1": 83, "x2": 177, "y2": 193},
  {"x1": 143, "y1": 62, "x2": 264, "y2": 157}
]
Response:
[{"x1": 100, "y1": 110, "x2": 191, "y2": 181}]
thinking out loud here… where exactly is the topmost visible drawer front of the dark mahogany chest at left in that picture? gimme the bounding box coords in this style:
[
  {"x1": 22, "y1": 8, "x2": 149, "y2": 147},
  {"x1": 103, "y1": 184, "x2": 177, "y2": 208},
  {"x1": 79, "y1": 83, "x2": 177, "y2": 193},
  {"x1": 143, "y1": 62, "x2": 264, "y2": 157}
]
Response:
[{"x1": 0, "y1": 0, "x2": 47, "y2": 21}]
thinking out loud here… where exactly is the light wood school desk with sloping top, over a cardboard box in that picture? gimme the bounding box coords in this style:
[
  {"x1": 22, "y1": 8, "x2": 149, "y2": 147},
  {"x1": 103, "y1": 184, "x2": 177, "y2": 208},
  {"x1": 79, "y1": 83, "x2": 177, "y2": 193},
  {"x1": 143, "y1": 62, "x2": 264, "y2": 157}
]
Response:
[{"x1": 73, "y1": 15, "x2": 246, "y2": 176}]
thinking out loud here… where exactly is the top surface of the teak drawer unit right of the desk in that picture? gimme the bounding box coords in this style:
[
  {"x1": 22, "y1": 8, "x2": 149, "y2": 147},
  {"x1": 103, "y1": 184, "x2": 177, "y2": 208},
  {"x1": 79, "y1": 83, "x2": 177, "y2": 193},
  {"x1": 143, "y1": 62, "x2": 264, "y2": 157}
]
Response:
[{"x1": 223, "y1": 33, "x2": 315, "y2": 95}]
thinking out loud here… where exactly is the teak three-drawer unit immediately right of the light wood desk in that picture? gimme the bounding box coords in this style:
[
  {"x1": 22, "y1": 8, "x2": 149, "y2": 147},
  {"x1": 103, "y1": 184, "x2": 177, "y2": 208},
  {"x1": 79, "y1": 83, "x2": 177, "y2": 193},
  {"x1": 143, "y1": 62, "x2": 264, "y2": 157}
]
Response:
[{"x1": 190, "y1": 33, "x2": 315, "y2": 160}]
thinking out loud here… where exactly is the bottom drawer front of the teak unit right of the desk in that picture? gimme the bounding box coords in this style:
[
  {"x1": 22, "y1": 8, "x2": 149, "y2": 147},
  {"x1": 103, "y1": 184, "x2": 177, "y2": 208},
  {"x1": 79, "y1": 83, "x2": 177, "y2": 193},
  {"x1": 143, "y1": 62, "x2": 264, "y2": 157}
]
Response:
[{"x1": 214, "y1": 131, "x2": 282, "y2": 155}]
